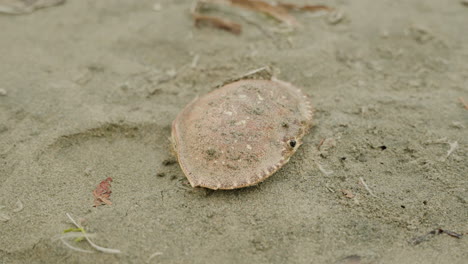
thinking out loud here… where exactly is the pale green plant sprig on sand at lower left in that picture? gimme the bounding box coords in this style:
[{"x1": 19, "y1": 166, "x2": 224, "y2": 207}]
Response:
[{"x1": 56, "y1": 213, "x2": 121, "y2": 254}]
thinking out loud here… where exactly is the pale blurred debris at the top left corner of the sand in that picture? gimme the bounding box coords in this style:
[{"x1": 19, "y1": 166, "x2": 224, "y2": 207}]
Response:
[{"x1": 0, "y1": 0, "x2": 65, "y2": 15}]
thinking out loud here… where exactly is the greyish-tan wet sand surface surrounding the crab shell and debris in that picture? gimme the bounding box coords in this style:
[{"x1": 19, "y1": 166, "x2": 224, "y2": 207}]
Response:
[{"x1": 0, "y1": 0, "x2": 468, "y2": 263}]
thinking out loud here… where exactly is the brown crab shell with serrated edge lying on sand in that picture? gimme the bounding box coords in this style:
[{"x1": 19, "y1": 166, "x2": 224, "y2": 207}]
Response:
[{"x1": 172, "y1": 80, "x2": 312, "y2": 190}]
